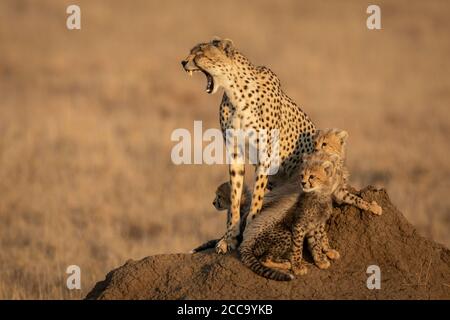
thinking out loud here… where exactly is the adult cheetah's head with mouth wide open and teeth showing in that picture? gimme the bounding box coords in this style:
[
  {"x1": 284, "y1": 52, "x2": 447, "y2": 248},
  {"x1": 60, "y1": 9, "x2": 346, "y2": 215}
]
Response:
[{"x1": 181, "y1": 39, "x2": 234, "y2": 93}]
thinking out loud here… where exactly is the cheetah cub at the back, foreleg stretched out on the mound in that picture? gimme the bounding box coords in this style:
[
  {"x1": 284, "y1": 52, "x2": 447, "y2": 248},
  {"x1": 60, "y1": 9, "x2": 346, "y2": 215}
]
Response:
[{"x1": 312, "y1": 129, "x2": 382, "y2": 215}]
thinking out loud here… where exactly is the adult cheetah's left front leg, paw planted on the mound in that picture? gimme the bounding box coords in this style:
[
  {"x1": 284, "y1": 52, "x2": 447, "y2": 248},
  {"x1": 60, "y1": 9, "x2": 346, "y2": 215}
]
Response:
[{"x1": 216, "y1": 162, "x2": 245, "y2": 254}]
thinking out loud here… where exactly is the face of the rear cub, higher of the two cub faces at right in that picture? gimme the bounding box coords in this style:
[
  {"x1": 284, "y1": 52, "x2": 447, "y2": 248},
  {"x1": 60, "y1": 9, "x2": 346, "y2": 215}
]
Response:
[{"x1": 314, "y1": 129, "x2": 348, "y2": 157}]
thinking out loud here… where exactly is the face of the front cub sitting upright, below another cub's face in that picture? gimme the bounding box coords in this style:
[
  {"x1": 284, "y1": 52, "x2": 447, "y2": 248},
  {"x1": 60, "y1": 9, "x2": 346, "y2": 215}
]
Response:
[{"x1": 300, "y1": 160, "x2": 334, "y2": 192}]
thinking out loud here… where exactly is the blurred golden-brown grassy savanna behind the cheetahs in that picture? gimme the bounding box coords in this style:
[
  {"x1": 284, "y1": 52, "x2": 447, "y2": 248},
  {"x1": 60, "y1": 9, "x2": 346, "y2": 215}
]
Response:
[{"x1": 0, "y1": 0, "x2": 450, "y2": 299}]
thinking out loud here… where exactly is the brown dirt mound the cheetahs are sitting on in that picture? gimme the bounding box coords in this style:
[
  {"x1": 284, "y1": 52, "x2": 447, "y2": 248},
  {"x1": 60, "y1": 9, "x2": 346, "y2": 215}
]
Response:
[{"x1": 86, "y1": 187, "x2": 450, "y2": 299}]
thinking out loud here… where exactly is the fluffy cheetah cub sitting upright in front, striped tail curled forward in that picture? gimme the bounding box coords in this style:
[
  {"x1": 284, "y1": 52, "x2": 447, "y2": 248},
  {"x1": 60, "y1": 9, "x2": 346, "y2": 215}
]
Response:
[{"x1": 240, "y1": 160, "x2": 339, "y2": 281}]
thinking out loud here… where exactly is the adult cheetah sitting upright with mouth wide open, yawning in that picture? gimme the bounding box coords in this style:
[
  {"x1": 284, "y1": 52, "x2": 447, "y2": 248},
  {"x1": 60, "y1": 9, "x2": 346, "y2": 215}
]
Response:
[{"x1": 181, "y1": 39, "x2": 316, "y2": 253}]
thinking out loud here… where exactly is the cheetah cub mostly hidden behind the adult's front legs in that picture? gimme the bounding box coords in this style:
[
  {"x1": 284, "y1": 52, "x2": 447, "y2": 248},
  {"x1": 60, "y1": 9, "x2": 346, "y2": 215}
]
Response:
[{"x1": 190, "y1": 182, "x2": 252, "y2": 253}]
